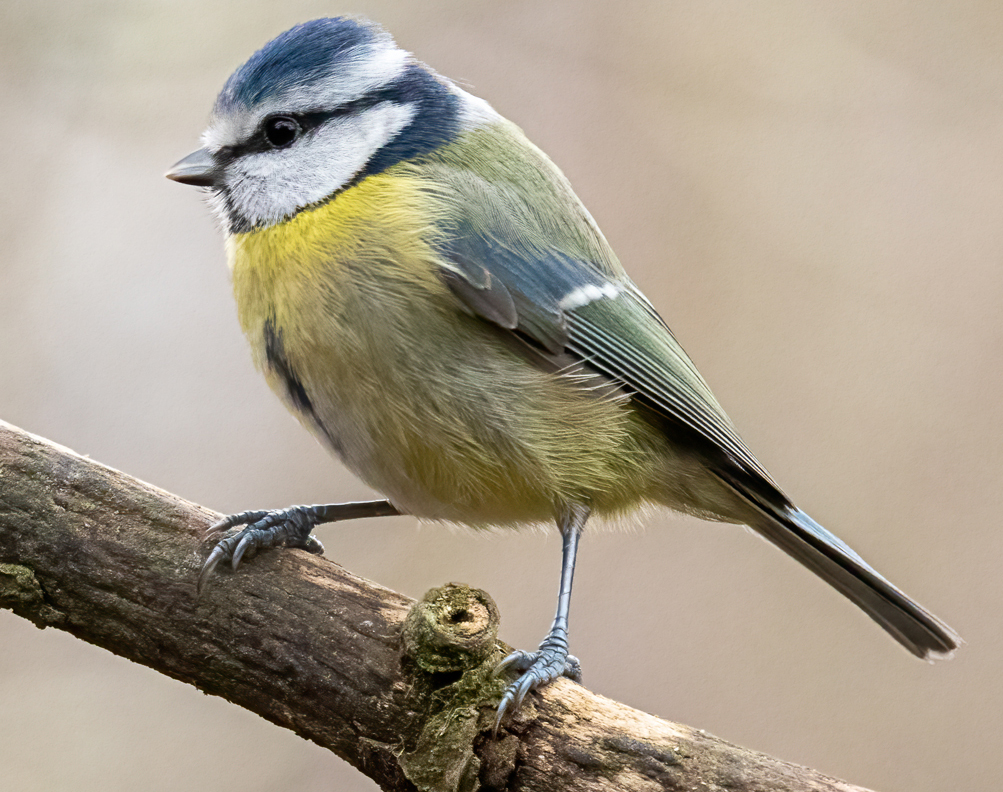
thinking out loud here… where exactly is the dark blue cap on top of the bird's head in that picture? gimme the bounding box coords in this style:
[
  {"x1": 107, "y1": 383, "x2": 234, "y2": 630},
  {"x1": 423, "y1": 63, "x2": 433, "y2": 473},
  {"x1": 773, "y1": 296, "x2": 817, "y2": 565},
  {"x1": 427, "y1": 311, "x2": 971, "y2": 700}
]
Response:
[{"x1": 216, "y1": 17, "x2": 393, "y2": 113}]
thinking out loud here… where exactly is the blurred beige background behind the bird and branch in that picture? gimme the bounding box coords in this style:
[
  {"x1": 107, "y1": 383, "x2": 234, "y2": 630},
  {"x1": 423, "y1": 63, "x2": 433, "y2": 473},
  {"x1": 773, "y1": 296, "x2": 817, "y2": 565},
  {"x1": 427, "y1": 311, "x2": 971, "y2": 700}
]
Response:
[{"x1": 0, "y1": 0, "x2": 1003, "y2": 792}]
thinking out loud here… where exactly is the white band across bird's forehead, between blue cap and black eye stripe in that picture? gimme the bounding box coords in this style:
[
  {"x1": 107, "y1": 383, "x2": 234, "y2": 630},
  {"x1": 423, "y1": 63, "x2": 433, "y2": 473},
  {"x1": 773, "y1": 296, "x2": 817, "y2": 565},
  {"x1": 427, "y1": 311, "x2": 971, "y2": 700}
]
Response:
[{"x1": 202, "y1": 38, "x2": 411, "y2": 151}]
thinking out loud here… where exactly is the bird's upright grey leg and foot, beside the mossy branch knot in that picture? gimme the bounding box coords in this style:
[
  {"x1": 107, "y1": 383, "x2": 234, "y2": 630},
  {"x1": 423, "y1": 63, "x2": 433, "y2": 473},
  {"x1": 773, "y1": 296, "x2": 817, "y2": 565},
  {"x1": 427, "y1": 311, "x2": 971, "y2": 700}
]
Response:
[{"x1": 494, "y1": 504, "x2": 589, "y2": 732}]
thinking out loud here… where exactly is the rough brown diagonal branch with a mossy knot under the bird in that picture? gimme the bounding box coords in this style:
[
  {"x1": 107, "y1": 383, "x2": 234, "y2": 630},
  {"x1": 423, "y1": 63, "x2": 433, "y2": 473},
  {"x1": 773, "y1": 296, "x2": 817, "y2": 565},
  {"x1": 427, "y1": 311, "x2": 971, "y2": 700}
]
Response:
[{"x1": 0, "y1": 422, "x2": 874, "y2": 792}]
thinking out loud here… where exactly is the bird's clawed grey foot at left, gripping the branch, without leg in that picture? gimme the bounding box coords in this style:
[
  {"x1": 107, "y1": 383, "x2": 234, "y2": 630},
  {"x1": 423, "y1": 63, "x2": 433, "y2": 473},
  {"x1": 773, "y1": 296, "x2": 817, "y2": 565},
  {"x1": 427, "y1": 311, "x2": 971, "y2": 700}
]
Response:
[{"x1": 198, "y1": 506, "x2": 329, "y2": 592}]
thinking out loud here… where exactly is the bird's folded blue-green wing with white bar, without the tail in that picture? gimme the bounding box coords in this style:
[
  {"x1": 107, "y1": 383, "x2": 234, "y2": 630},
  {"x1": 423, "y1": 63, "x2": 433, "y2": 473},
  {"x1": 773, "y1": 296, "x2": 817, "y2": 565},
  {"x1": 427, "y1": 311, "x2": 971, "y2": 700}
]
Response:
[{"x1": 427, "y1": 156, "x2": 786, "y2": 503}]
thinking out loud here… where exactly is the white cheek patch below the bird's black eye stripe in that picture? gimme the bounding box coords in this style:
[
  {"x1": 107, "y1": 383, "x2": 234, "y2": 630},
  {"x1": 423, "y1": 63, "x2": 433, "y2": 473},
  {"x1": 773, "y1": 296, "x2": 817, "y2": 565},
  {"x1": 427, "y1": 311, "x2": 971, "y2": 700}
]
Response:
[{"x1": 226, "y1": 102, "x2": 415, "y2": 226}]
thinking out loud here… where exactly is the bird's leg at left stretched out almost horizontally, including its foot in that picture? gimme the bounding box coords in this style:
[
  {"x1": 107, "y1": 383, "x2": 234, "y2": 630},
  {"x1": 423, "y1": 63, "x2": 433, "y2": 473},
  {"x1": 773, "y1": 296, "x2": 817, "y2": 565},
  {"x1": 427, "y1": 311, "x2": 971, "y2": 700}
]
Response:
[{"x1": 198, "y1": 500, "x2": 400, "y2": 592}]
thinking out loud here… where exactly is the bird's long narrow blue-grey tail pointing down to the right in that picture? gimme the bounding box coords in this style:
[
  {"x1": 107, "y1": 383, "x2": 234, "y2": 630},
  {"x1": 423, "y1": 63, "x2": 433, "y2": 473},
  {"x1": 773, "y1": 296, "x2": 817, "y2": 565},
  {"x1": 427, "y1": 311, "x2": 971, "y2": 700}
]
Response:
[{"x1": 722, "y1": 476, "x2": 961, "y2": 661}]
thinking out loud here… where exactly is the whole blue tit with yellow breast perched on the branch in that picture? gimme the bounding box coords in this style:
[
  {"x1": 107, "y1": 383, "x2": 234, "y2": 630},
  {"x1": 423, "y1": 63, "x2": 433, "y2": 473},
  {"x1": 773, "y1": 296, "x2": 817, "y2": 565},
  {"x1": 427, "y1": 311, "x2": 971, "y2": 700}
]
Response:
[{"x1": 166, "y1": 18, "x2": 960, "y2": 722}]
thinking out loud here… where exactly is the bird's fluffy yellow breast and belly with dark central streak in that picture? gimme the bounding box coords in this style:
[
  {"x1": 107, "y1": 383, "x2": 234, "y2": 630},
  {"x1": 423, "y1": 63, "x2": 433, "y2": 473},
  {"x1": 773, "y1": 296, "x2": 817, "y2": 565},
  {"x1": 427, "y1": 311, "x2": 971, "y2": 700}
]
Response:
[{"x1": 222, "y1": 171, "x2": 670, "y2": 524}]
